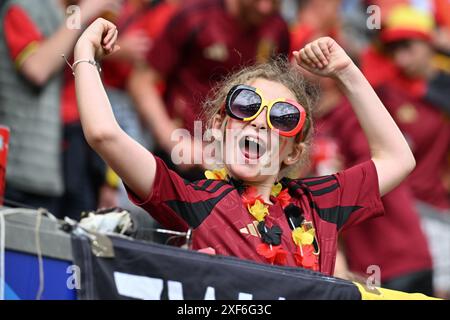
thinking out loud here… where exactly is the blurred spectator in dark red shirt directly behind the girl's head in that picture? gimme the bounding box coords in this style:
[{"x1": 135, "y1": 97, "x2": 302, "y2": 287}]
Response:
[{"x1": 126, "y1": 0, "x2": 289, "y2": 178}]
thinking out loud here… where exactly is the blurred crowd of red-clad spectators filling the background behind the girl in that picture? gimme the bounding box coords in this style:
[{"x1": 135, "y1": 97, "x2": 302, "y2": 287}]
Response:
[{"x1": 0, "y1": 0, "x2": 450, "y2": 298}]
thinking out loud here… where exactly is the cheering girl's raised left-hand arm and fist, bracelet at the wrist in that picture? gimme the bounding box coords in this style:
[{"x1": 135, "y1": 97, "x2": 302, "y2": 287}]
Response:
[{"x1": 74, "y1": 18, "x2": 156, "y2": 199}]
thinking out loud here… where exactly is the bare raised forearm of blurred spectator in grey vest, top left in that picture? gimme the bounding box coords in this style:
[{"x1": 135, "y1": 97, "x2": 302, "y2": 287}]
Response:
[{"x1": 11, "y1": 0, "x2": 120, "y2": 86}]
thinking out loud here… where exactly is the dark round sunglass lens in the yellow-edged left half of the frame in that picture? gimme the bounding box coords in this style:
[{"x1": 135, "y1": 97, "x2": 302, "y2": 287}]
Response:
[{"x1": 230, "y1": 89, "x2": 261, "y2": 119}]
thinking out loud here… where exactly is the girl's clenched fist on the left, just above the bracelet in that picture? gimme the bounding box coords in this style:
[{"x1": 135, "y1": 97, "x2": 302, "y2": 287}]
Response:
[{"x1": 75, "y1": 18, "x2": 120, "y2": 60}]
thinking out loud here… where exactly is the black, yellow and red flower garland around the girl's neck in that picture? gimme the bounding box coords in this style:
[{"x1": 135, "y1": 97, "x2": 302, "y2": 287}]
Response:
[{"x1": 205, "y1": 168, "x2": 320, "y2": 271}]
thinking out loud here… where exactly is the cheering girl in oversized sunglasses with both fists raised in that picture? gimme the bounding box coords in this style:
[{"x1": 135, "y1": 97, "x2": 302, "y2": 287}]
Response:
[{"x1": 75, "y1": 19, "x2": 415, "y2": 274}]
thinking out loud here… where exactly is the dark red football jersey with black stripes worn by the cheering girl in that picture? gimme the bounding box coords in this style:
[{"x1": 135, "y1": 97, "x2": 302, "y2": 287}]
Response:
[{"x1": 129, "y1": 157, "x2": 384, "y2": 275}]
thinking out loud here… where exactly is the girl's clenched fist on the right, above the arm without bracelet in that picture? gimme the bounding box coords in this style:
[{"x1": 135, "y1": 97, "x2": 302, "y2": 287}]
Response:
[{"x1": 293, "y1": 37, "x2": 353, "y2": 78}]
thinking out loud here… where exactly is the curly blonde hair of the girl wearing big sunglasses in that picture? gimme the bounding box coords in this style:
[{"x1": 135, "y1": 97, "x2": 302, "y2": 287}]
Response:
[{"x1": 200, "y1": 58, "x2": 319, "y2": 178}]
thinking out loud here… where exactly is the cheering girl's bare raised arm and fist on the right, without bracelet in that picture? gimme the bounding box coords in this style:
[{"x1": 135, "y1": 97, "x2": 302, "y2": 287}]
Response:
[{"x1": 294, "y1": 37, "x2": 416, "y2": 195}]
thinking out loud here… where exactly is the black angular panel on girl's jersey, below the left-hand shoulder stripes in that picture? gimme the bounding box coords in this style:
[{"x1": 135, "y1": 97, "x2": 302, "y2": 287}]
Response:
[{"x1": 165, "y1": 186, "x2": 235, "y2": 228}]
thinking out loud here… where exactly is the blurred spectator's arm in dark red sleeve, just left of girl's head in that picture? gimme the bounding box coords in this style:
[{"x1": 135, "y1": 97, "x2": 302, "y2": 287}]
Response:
[{"x1": 127, "y1": 5, "x2": 202, "y2": 165}]
